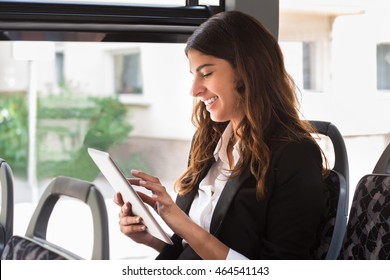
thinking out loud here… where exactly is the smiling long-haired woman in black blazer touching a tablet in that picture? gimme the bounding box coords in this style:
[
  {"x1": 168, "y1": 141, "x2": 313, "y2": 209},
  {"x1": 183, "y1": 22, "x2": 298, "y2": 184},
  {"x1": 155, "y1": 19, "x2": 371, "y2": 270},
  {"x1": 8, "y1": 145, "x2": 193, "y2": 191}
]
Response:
[{"x1": 114, "y1": 11, "x2": 324, "y2": 259}]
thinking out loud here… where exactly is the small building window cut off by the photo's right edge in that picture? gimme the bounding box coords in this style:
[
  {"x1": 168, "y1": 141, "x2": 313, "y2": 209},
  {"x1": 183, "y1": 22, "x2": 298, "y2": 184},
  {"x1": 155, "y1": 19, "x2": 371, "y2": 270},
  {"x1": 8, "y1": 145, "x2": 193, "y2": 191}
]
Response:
[{"x1": 376, "y1": 43, "x2": 390, "y2": 90}]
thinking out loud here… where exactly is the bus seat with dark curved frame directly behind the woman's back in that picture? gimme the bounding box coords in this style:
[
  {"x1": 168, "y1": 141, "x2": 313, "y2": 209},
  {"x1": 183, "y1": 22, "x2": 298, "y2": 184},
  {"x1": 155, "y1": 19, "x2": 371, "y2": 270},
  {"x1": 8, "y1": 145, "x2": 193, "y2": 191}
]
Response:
[{"x1": 310, "y1": 121, "x2": 349, "y2": 260}]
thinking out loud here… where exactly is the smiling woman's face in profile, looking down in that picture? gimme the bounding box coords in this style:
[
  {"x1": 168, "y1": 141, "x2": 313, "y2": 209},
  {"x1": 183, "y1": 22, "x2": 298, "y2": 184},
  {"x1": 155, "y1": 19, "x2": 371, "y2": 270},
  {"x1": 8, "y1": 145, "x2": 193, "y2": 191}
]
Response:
[{"x1": 187, "y1": 49, "x2": 244, "y2": 126}]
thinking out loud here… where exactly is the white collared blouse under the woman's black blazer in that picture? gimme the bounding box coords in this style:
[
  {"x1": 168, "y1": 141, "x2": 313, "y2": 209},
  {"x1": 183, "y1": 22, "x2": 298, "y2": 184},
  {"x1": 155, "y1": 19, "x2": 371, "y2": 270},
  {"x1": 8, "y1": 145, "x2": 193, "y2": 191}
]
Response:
[{"x1": 184, "y1": 124, "x2": 247, "y2": 260}]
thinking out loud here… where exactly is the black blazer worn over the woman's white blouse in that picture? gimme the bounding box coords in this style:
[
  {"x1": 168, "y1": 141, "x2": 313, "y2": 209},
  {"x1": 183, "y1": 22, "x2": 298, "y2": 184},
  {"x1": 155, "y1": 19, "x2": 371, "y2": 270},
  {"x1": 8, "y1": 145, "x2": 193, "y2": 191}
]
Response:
[{"x1": 157, "y1": 141, "x2": 325, "y2": 259}]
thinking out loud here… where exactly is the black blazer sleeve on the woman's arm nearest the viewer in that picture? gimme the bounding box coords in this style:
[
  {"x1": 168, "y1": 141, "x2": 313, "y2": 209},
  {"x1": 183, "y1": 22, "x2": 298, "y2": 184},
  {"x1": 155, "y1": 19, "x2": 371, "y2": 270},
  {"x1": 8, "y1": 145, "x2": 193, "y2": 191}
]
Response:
[{"x1": 261, "y1": 141, "x2": 325, "y2": 259}]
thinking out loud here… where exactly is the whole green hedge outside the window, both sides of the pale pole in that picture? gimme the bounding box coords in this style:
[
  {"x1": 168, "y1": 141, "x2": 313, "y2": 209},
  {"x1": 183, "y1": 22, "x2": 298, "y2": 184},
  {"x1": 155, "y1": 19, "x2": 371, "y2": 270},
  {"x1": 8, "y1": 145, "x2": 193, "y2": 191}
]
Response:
[{"x1": 0, "y1": 88, "x2": 150, "y2": 181}]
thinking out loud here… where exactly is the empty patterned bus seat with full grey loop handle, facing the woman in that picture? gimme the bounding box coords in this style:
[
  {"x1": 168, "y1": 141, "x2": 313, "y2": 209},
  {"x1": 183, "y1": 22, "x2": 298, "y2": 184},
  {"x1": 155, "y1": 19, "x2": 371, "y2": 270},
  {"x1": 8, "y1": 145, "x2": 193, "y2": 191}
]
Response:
[{"x1": 2, "y1": 176, "x2": 109, "y2": 260}]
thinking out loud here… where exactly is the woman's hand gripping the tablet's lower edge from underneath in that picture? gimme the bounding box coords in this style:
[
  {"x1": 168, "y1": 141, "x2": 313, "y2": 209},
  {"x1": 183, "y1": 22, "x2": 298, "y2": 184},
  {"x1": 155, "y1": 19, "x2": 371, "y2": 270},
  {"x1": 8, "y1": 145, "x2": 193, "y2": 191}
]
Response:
[{"x1": 114, "y1": 193, "x2": 165, "y2": 252}]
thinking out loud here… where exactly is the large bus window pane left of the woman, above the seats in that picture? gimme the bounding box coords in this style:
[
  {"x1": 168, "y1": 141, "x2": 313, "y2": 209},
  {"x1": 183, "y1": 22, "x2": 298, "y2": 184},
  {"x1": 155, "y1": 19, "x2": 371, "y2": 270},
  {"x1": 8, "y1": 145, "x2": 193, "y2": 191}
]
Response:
[{"x1": 0, "y1": 41, "x2": 194, "y2": 210}]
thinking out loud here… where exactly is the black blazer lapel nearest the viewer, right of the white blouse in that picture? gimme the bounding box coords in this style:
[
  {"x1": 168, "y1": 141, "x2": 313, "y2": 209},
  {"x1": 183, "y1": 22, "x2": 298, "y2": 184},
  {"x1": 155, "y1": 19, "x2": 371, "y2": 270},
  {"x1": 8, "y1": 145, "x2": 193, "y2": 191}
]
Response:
[{"x1": 210, "y1": 168, "x2": 251, "y2": 235}]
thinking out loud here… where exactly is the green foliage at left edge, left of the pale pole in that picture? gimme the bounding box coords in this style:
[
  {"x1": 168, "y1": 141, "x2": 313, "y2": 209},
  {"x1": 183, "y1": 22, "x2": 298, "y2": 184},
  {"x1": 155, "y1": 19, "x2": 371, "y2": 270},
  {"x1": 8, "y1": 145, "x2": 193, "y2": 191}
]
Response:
[{"x1": 0, "y1": 93, "x2": 28, "y2": 175}]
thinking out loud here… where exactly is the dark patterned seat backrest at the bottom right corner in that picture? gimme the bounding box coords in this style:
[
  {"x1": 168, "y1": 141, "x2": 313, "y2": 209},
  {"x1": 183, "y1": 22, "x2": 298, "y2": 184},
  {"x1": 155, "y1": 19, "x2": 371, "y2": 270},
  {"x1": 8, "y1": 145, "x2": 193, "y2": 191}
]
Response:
[{"x1": 339, "y1": 174, "x2": 390, "y2": 260}]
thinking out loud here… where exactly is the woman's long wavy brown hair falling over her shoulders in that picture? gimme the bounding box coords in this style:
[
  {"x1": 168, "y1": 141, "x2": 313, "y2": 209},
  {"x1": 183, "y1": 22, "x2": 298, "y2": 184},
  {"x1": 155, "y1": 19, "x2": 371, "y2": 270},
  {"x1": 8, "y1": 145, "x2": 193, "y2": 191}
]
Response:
[{"x1": 175, "y1": 11, "x2": 324, "y2": 198}]
